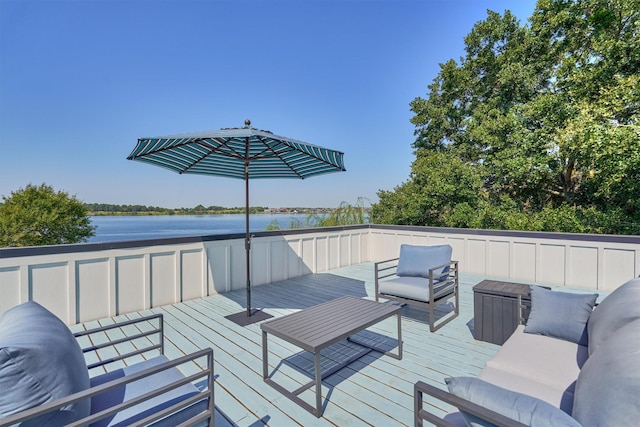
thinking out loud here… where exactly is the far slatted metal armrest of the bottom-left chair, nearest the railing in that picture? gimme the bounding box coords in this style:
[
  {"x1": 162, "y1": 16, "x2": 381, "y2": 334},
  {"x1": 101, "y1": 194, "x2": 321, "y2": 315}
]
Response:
[{"x1": 73, "y1": 314, "x2": 164, "y2": 369}]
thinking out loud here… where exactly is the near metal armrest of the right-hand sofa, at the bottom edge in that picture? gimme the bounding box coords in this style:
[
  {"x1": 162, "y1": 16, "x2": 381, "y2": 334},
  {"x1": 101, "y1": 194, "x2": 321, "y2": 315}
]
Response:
[{"x1": 413, "y1": 381, "x2": 526, "y2": 427}]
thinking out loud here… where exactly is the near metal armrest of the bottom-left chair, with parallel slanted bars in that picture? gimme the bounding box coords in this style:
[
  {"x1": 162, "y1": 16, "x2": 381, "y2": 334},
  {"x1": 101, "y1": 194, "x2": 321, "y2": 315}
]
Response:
[{"x1": 0, "y1": 348, "x2": 214, "y2": 426}]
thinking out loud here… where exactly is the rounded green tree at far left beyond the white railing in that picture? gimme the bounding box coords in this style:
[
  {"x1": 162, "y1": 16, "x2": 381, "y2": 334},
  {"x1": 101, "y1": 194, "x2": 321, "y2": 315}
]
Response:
[{"x1": 0, "y1": 184, "x2": 95, "y2": 247}]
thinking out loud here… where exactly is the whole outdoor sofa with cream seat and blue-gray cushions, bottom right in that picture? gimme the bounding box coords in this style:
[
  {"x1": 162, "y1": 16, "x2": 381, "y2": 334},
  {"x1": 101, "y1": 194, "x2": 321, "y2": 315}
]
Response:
[{"x1": 414, "y1": 278, "x2": 640, "y2": 427}]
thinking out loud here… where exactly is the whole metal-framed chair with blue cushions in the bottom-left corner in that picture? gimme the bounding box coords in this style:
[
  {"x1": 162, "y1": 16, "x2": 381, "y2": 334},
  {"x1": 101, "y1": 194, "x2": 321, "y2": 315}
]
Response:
[{"x1": 0, "y1": 302, "x2": 214, "y2": 427}]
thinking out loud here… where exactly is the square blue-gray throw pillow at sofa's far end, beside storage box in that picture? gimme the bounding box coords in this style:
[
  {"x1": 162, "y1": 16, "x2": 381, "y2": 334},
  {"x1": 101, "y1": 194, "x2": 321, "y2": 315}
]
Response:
[{"x1": 524, "y1": 286, "x2": 598, "y2": 345}]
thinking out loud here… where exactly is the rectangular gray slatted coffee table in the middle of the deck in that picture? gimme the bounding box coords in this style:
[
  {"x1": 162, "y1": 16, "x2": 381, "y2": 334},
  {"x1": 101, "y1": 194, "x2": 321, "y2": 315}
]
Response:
[{"x1": 260, "y1": 296, "x2": 402, "y2": 417}]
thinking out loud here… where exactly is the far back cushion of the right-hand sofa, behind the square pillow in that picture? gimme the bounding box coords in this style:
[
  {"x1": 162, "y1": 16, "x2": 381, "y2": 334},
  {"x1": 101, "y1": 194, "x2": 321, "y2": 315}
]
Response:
[{"x1": 587, "y1": 278, "x2": 640, "y2": 354}]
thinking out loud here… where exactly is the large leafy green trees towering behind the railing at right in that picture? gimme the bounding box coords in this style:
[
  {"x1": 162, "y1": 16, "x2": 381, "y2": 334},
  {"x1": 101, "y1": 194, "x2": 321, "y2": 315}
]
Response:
[{"x1": 372, "y1": 0, "x2": 640, "y2": 233}]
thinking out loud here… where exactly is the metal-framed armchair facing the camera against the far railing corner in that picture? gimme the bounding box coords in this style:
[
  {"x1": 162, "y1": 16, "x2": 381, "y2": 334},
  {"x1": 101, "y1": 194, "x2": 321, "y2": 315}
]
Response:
[{"x1": 375, "y1": 245, "x2": 460, "y2": 332}]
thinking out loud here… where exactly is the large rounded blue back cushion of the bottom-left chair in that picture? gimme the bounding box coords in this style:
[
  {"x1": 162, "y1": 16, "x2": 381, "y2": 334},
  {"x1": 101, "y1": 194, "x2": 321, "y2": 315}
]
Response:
[{"x1": 0, "y1": 301, "x2": 90, "y2": 426}]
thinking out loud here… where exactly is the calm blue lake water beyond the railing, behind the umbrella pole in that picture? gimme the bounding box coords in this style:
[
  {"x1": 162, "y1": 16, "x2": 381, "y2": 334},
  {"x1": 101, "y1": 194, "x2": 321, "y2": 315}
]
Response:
[{"x1": 88, "y1": 214, "x2": 307, "y2": 243}]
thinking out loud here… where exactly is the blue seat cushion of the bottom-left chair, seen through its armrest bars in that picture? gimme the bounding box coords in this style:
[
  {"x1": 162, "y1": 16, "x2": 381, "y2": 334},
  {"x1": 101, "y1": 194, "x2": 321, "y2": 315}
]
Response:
[{"x1": 91, "y1": 356, "x2": 208, "y2": 427}]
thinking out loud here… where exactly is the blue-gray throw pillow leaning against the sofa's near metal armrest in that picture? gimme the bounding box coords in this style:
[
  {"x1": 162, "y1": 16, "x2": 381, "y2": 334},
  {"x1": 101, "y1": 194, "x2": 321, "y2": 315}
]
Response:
[{"x1": 445, "y1": 377, "x2": 580, "y2": 427}]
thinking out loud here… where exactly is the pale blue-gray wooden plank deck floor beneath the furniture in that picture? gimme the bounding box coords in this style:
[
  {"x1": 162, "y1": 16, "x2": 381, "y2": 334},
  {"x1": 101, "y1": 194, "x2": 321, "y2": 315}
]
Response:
[{"x1": 76, "y1": 263, "x2": 499, "y2": 426}]
